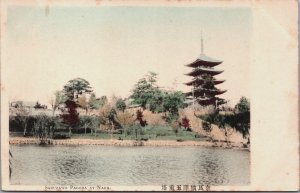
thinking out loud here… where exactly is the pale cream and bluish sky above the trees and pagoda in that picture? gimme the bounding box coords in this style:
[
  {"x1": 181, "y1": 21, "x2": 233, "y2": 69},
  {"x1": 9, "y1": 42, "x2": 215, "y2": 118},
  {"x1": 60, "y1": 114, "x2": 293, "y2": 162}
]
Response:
[{"x1": 5, "y1": 6, "x2": 252, "y2": 105}]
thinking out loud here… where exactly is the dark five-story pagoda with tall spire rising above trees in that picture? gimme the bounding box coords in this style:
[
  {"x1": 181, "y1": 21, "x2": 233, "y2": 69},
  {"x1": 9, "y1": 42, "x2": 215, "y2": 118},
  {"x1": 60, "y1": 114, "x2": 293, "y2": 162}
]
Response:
[{"x1": 186, "y1": 35, "x2": 226, "y2": 108}]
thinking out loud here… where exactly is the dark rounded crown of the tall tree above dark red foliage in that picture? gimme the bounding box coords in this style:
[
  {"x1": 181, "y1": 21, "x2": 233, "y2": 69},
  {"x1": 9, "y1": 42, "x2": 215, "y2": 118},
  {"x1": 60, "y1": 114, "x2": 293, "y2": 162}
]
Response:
[{"x1": 63, "y1": 78, "x2": 93, "y2": 102}]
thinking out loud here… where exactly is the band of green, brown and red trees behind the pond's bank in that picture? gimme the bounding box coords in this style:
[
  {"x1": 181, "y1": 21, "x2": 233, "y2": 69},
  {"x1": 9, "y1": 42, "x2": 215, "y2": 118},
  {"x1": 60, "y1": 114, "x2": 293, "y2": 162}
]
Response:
[{"x1": 10, "y1": 72, "x2": 250, "y2": 144}]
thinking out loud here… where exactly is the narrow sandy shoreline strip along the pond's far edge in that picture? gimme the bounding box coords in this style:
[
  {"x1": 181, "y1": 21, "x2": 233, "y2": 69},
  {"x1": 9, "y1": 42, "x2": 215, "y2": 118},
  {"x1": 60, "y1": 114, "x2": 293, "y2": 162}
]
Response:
[{"x1": 9, "y1": 137, "x2": 250, "y2": 151}]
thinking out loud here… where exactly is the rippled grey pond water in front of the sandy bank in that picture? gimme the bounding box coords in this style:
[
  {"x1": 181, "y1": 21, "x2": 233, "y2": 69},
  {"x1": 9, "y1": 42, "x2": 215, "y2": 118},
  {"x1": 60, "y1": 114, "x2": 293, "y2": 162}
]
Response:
[{"x1": 10, "y1": 145, "x2": 250, "y2": 186}]
